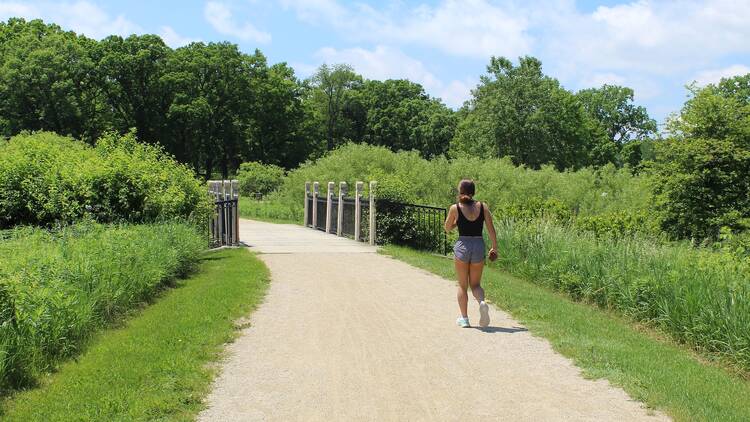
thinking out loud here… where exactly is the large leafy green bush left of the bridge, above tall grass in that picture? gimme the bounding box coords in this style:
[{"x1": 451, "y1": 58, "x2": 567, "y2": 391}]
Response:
[{"x1": 0, "y1": 132, "x2": 211, "y2": 228}]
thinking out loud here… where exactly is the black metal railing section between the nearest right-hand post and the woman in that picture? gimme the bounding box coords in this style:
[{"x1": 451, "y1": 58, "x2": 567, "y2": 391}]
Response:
[{"x1": 374, "y1": 199, "x2": 448, "y2": 255}]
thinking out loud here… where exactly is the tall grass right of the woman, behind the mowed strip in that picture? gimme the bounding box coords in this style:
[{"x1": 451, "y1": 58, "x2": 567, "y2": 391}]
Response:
[{"x1": 496, "y1": 220, "x2": 750, "y2": 371}]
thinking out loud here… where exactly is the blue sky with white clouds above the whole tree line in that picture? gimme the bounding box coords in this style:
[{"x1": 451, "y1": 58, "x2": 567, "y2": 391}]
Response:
[{"x1": 0, "y1": 0, "x2": 750, "y2": 123}]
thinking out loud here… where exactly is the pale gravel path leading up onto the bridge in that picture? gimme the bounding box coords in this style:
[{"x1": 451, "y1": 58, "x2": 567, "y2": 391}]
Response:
[{"x1": 199, "y1": 220, "x2": 667, "y2": 421}]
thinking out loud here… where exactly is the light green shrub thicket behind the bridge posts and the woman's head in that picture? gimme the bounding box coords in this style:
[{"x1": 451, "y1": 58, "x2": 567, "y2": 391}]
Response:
[{"x1": 260, "y1": 144, "x2": 657, "y2": 234}]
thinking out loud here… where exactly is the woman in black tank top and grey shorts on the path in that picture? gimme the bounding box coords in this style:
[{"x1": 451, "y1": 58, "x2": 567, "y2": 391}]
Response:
[{"x1": 445, "y1": 180, "x2": 497, "y2": 328}]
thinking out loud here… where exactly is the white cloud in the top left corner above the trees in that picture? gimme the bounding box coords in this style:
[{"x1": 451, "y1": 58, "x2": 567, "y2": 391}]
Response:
[{"x1": 0, "y1": 0, "x2": 143, "y2": 39}]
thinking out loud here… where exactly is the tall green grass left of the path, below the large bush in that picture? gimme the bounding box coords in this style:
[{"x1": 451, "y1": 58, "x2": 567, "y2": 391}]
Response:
[{"x1": 0, "y1": 222, "x2": 205, "y2": 391}]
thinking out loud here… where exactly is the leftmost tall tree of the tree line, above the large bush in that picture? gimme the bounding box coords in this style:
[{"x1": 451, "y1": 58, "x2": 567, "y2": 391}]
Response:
[{"x1": 0, "y1": 18, "x2": 105, "y2": 141}]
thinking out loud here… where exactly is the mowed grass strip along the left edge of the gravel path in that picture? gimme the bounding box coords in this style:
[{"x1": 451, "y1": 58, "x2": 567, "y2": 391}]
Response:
[{"x1": 1, "y1": 249, "x2": 269, "y2": 421}]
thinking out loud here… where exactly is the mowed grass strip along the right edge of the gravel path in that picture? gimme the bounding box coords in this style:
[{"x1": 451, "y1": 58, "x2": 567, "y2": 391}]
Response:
[{"x1": 382, "y1": 246, "x2": 750, "y2": 421}]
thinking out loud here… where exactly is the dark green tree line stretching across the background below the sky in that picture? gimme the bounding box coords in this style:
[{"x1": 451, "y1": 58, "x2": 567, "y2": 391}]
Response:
[{"x1": 0, "y1": 18, "x2": 656, "y2": 177}]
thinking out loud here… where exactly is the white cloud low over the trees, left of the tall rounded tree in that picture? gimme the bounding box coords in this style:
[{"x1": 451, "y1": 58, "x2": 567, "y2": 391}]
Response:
[{"x1": 315, "y1": 45, "x2": 476, "y2": 108}]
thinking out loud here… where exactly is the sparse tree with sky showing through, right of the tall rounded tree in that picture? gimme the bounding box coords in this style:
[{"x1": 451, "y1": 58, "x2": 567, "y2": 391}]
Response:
[{"x1": 576, "y1": 85, "x2": 657, "y2": 165}]
